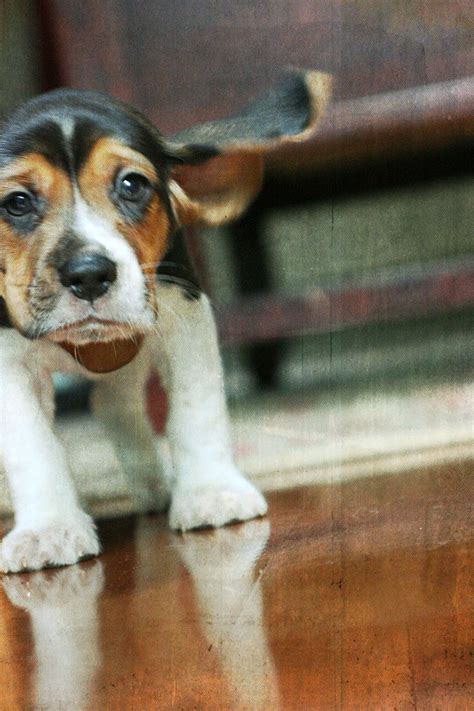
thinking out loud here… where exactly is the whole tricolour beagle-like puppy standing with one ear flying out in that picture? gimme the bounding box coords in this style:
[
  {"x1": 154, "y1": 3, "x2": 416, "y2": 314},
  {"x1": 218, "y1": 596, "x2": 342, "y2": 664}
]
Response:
[{"x1": 0, "y1": 71, "x2": 328, "y2": 571}]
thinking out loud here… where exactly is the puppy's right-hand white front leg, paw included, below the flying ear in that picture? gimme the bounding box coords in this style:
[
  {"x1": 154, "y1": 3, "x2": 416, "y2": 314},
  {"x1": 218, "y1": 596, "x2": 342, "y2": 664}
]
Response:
[{"x1": 157, "y1": 286, "x2": 267, "y2": 531}]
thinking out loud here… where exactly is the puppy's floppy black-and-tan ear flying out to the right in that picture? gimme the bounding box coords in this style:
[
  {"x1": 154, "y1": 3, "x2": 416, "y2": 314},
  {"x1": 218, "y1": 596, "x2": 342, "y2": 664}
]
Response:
[{"x1": 168, "y1": 70, "x2": 331, "y2": 225}]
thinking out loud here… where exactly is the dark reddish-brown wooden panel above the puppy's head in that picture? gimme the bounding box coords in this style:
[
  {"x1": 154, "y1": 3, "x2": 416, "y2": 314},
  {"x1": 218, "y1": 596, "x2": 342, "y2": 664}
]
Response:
[{"x1": 43, "y1": 0, "x2": 474, "y2": 133}]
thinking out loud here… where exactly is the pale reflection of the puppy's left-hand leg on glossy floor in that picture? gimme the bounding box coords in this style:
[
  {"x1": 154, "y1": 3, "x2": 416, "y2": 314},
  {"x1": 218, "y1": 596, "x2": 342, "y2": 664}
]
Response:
[{"x1": 3, "y1": 562, "x2": 104, "y2": 709}]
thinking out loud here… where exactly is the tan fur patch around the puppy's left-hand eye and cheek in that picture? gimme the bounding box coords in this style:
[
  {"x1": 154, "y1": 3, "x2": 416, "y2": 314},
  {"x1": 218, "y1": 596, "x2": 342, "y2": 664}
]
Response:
[{"x1": 0, "y1": 153, "x2": 72, "y2": 330}]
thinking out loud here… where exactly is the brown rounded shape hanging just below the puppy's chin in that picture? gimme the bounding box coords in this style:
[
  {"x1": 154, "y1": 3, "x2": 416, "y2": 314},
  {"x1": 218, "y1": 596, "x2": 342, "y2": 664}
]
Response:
[{"x1": 59, "y1": 336, "x2": 143, "y2": 373}]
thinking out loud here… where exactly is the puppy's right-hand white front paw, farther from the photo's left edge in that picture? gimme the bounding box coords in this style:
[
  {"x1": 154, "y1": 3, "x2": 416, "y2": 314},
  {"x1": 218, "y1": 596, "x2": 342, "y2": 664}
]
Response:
[{"x1": 169, "y1": 474, "x2": 267, "y2": 531}]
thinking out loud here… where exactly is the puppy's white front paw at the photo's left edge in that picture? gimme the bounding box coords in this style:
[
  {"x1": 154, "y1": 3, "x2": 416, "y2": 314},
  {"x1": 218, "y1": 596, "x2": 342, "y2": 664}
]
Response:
[{"x1": 0, "y1": 512, "x2": 99, "y2": 573}]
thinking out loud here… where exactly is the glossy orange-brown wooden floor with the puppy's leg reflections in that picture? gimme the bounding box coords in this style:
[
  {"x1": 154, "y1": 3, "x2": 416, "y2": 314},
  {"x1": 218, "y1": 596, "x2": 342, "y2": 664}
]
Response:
[{"x1": 0, "y1": 463, "x2": 474, "y2": 711}]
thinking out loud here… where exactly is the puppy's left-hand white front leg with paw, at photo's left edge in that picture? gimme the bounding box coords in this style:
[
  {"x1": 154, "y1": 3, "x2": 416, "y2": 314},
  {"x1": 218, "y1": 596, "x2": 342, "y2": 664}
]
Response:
[{"x1": 0, "y1": 353, "x2": 99, "y2": 572}]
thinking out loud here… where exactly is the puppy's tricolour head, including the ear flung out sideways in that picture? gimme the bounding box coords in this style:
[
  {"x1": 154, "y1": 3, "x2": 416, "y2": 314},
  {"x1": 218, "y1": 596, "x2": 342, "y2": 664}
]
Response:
[{"x1": 0, "y1": 72, "x2": 328, "y2": 345}]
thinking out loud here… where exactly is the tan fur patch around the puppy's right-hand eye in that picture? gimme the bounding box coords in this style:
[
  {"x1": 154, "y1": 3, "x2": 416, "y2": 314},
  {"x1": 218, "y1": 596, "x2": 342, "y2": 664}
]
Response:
[{"x1": 78, "y1": 138, "x2": 170, "y2": 292}]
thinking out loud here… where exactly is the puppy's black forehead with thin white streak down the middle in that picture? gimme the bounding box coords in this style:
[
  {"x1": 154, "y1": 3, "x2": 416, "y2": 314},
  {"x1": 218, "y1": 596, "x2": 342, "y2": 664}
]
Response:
[{"x1": 0, "y1": 90, "x2": 167, "y2": 175}]
